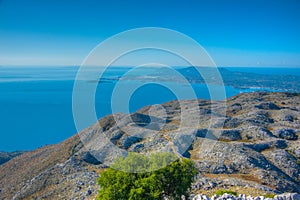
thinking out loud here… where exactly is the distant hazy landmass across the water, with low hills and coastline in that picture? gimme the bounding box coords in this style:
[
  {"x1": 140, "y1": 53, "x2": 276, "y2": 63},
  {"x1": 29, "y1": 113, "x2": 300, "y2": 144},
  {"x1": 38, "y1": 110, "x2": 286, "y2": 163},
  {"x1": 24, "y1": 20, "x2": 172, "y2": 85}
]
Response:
[{"x1": 114, "y1": 67, "x2": 300, "y2": 93}]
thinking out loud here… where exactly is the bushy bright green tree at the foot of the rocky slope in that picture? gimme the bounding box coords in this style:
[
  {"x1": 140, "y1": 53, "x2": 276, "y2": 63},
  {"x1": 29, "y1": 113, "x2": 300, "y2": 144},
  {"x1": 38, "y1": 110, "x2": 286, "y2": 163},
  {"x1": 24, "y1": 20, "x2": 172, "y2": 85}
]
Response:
[{"x1": 97, "y1": 153, "x2": 197, "y2": 200}]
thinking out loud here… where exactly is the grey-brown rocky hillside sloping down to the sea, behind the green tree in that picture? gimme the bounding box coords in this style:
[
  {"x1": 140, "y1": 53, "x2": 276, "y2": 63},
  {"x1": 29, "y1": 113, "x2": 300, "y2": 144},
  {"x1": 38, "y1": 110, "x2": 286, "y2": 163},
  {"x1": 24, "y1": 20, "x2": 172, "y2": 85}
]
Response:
[{"x1": 0, "y1": 93, "x2": 300, "y2": 199}]
